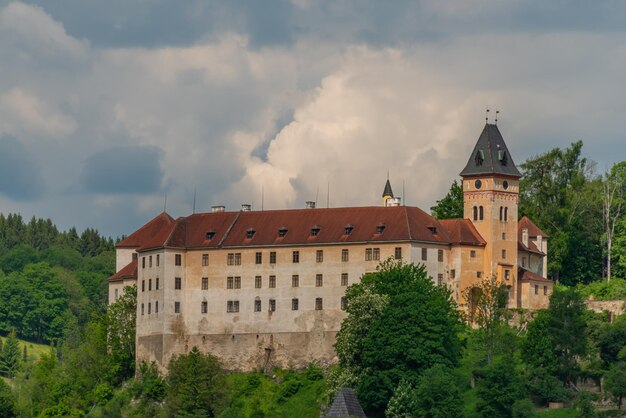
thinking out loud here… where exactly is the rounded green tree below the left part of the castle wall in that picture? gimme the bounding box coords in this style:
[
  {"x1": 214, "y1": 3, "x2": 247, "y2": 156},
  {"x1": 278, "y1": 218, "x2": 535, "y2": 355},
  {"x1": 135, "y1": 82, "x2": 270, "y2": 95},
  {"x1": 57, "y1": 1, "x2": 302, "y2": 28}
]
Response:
[{"x1": 166, "y1": 347, "x2": 227, "y2": 417}]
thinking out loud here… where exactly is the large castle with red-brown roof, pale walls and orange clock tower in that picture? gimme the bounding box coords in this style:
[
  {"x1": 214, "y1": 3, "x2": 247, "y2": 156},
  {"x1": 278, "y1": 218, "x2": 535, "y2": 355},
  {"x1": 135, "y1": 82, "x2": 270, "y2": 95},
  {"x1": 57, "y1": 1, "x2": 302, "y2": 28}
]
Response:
[{"x1": 109, "y1": 123, "x2": 553, "y2": 370}]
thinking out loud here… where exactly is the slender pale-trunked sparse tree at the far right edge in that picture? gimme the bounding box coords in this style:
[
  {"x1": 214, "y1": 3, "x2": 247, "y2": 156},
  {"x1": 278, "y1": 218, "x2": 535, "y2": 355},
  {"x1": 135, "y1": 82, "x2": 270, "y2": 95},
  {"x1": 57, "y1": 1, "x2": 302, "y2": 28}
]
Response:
[{"x1": 602, "y1": 161, "x2": 626, "y2": 281}]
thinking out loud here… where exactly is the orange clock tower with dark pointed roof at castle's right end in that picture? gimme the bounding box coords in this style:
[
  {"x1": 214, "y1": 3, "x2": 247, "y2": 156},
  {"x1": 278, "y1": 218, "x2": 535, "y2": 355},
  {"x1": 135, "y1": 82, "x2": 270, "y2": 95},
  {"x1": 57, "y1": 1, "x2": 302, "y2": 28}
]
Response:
[{"x1": 461, "y1": 123, "x2": 521, "y2": 307}]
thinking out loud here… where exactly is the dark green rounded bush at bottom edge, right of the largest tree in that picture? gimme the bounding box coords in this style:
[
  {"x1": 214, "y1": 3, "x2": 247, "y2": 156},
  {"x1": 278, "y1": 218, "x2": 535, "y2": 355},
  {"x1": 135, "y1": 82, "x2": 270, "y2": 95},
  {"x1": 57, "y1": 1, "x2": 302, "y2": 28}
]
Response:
[{"x1": 476, "y1": 360, "x2": 525, "y2": 418}]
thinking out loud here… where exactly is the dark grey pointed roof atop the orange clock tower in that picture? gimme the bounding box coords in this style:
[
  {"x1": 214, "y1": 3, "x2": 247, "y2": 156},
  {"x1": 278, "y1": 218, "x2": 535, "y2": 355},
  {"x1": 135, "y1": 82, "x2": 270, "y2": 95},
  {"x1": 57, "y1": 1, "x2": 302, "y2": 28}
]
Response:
[{"x1": 461, "y1": 123, "x2": 522, "y2": 177}]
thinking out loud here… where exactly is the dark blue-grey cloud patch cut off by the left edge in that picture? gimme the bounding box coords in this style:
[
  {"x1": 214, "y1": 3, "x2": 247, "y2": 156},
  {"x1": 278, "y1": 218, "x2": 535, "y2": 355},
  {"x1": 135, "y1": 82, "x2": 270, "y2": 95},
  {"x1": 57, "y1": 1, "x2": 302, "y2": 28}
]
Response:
[{"x1": 0, "y1": 136, "x2": 44, "y2": 200}]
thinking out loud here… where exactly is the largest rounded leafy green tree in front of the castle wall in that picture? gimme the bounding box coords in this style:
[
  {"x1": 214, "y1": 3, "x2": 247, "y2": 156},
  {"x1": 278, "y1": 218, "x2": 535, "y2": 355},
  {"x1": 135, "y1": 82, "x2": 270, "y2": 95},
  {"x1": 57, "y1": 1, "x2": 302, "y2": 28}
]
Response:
[{"x1": 335, "y1": 260, "x2": 462, "y2": 417}]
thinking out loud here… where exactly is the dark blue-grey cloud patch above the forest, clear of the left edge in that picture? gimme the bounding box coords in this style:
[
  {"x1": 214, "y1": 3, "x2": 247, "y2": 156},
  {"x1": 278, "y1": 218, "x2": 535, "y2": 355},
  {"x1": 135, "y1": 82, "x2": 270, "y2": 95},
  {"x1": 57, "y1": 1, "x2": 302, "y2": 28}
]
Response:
[{"x1": 82, "y1": 146, "x2": 163, "y2": 194}]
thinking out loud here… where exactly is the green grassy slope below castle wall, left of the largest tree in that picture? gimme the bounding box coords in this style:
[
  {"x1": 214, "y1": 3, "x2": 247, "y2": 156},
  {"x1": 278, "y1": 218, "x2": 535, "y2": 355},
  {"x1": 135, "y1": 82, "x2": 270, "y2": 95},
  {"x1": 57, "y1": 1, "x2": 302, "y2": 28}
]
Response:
[{"x1": 219, "y1": 370, "x2": 325, "y2": 418}]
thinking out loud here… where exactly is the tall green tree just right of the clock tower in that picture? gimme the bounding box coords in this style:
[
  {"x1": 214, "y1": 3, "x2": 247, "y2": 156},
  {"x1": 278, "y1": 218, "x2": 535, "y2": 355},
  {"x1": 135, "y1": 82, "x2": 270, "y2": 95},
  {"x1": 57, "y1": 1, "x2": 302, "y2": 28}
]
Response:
[{"x1": 520, "y1": 141, "x2": 603, "y2": 285}]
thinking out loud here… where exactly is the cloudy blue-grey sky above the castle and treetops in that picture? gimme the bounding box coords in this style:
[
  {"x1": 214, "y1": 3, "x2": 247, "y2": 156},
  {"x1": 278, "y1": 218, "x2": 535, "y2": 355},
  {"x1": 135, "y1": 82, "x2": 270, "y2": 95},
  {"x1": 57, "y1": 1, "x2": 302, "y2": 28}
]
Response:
[{"x1": 0, "y1": 0, "x2": 626, "y2": 237}]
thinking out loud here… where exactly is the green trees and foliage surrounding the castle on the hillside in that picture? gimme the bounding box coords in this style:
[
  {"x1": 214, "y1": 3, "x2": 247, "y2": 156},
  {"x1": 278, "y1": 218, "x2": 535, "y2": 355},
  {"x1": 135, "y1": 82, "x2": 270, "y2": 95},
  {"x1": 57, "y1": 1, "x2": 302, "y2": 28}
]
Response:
[{"x1": 0, "y1": 142, "x2": 626, "y2": 417}]
